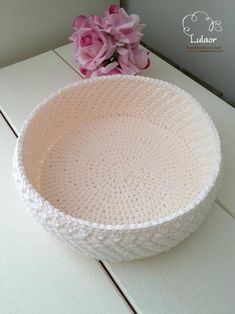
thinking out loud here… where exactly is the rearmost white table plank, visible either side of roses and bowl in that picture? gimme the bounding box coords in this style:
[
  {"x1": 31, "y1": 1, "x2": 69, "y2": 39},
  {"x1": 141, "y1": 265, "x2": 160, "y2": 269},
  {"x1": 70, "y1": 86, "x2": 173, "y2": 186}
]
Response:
[{"x1": 56, "y1": 44, "x2": 235, "y2": 216}]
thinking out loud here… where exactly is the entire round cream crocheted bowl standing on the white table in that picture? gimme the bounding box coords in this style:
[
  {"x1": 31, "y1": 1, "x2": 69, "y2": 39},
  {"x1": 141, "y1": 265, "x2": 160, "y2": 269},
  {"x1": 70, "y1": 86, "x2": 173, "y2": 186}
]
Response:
[{"x1": 14, "y1": 75, "x2": 221, "y2": 261}]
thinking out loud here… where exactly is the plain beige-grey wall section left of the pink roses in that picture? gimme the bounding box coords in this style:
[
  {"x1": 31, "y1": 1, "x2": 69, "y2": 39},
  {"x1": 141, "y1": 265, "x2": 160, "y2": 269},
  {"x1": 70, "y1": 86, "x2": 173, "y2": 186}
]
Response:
[{"x1": 0, "y1": 0, "x2": 118, "y2": 67}]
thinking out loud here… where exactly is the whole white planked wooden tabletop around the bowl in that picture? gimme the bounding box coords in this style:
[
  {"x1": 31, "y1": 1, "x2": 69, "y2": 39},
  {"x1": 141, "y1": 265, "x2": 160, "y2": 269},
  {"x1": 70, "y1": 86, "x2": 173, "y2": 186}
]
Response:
[{"x1": 0, "y1": 45, "x2": 235, "y2": 314}]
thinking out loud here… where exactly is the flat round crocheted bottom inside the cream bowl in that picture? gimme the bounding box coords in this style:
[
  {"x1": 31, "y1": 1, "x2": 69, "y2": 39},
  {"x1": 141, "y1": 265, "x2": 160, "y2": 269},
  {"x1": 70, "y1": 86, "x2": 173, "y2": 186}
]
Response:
[{"x1": 40, "y1": 116, "x2": 206, "y2": 224}]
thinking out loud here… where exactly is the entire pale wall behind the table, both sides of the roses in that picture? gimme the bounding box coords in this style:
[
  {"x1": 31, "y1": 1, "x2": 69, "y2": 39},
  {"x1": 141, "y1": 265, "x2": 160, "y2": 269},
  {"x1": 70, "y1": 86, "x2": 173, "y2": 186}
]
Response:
[{"x1": 0, "y1": 0, "x2": 235, "y2": 104}]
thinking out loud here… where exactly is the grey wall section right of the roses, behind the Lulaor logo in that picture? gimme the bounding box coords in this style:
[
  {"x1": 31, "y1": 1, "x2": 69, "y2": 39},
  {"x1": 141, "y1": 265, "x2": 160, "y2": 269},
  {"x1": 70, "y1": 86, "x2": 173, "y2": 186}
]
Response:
[{"x1": 121, "y1": 0, "x2": 235, "y2": 104}]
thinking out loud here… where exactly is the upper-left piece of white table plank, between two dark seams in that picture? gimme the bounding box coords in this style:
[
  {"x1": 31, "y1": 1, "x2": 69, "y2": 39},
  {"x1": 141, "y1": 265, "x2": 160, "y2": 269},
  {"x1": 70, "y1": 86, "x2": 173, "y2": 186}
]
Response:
[{"x1": 0, "y1": 52, "x2": 81, "y2": 132}]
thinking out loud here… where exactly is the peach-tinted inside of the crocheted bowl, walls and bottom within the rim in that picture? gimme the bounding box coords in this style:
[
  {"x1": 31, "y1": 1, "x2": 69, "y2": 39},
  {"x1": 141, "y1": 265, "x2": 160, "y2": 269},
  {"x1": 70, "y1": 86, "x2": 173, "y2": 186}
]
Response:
[{"x1": 22, "y1": 77, "x2": 216, "y2": 224}]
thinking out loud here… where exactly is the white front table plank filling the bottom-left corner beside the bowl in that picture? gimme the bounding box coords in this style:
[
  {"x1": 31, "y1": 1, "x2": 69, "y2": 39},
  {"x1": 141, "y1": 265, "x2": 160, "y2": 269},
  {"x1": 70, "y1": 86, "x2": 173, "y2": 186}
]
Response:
[{"x1": 0, "y1": 115, "x2": 130, "y2": 314}]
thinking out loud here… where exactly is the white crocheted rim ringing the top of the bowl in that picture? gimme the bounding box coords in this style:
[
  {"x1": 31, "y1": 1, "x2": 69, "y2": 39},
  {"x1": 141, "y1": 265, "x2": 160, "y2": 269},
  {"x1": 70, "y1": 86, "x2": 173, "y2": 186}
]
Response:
[{"x1": 13, "y1": 74, "x2": 222, "y2": 230}]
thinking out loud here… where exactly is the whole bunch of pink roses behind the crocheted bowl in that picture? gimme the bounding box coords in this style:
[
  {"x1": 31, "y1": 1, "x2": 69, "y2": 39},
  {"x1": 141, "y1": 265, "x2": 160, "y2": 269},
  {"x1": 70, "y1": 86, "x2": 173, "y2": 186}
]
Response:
[{"x1": 70, "y1": 4, "x2": 150, "y2": 77}]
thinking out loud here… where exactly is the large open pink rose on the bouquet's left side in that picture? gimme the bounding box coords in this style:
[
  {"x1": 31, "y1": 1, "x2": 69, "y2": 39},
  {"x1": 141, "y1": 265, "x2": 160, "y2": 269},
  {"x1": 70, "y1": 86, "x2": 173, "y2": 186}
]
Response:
[{"x1": 70, "y1": 16, "x2": 116, "y2": 71}]
